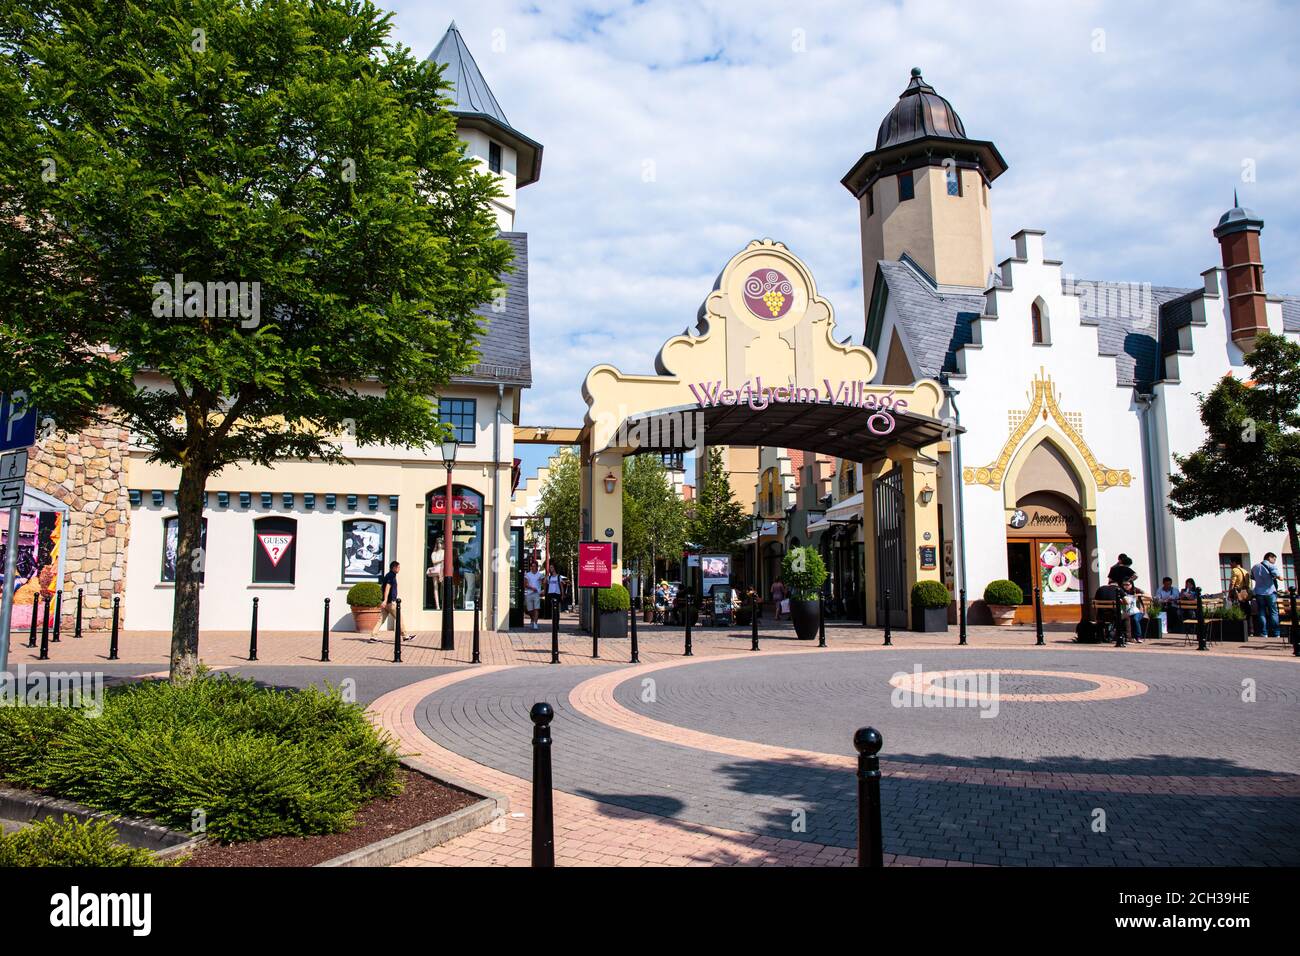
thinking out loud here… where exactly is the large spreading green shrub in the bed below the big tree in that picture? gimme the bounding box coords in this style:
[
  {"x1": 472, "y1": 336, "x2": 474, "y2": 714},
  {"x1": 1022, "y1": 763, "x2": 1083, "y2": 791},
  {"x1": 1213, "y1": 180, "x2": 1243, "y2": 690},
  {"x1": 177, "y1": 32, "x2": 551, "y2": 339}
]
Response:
[{"x1": 0, "y1": 675, "x2": 399, "y2": 842}]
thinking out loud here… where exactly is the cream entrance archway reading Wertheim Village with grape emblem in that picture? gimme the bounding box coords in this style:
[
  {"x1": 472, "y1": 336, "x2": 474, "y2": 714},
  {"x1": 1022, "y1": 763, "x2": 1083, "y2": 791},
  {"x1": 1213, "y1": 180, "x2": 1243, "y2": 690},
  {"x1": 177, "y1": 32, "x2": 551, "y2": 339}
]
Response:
[{"x1": 580, "y1": 239, "x2": 957, "y2": 629}]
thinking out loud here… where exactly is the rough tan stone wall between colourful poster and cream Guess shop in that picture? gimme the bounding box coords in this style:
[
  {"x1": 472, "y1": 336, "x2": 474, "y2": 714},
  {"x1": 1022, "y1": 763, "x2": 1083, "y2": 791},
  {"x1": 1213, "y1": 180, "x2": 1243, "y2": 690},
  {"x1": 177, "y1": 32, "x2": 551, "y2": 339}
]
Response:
[{"x1": 27, "y1": 425, "x2": 131, "y2": 635}]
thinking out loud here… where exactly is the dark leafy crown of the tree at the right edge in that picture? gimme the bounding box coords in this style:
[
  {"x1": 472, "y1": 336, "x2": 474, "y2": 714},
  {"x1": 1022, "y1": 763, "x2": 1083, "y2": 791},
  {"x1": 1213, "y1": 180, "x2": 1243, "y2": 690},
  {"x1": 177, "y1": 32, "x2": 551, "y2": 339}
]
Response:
[{"x1": 1169, "y1": 334, "x2": 1300, "y2": 564}]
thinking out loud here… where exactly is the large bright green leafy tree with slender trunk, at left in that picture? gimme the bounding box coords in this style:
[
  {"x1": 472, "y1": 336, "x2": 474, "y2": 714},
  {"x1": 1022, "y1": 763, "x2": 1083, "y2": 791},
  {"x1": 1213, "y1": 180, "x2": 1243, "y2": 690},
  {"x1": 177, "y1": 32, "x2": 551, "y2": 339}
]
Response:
[{"x1": 0, "y1": 0, "x2": 510, "y2": 679}]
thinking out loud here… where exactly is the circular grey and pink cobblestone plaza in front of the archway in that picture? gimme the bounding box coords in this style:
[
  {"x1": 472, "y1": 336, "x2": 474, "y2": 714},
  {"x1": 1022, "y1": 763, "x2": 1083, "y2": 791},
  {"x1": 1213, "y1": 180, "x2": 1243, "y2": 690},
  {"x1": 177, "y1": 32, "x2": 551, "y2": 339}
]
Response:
[{"x1": 376, "y1": 645, "x2": 1300, "y2": 865}]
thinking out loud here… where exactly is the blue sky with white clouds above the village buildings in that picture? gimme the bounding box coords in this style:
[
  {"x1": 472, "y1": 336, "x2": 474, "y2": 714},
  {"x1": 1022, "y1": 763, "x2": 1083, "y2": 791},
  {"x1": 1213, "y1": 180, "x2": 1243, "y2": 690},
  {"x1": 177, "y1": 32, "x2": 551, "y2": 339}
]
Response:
[{"x1": 378, "y1": 0, "x2": 1300, "y2": 477}]
